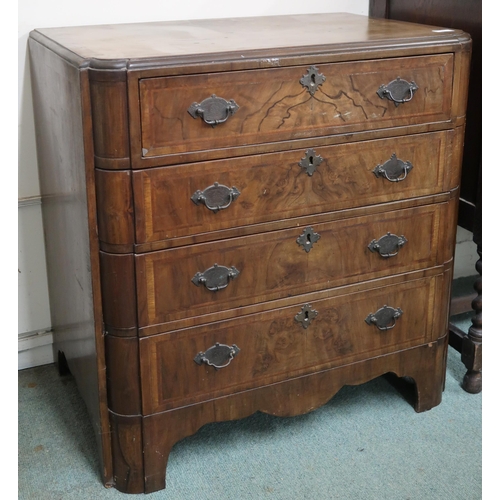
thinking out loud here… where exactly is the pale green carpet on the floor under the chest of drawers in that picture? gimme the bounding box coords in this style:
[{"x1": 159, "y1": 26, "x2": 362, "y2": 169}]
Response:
[{"x1": 18, "y1": 349, "x2": 482, "y2": 500}]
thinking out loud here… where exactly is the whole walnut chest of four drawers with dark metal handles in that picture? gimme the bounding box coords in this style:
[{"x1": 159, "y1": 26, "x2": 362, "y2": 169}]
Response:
[{"x1": 29, "y1": 14, "x2": 471, "y2": 493}]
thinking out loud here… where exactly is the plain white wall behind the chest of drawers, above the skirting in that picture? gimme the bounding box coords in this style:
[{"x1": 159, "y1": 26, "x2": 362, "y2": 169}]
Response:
[{"x1": 18, "y1": 0, "x2": 478, "y2": 364}]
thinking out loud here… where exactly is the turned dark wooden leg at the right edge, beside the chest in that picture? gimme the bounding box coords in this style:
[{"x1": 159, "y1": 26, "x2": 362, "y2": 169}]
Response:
[{"x1": 462, "y1": 243, "x2": 483, "y2": 394}]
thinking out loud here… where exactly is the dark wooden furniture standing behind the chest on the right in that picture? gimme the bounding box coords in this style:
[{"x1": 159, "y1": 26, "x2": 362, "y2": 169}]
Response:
[{"x1": 369, "y1": 0, "x2": 483, "y2": 394}]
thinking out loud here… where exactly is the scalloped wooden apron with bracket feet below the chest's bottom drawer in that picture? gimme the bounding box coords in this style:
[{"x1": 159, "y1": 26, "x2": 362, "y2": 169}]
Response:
[{"x1": 144, "y1": 337, "x2": 447, "y2": 492}]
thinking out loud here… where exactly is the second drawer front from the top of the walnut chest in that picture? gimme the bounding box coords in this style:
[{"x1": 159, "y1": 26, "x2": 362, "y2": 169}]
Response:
[{"x1": 133, "y1": 131, "x2": 453, "y2": 243}]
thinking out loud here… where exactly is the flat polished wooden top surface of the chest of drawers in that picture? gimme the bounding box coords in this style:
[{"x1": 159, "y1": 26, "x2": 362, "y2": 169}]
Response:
[{"x1": 36, "y1": 13, "x2": 462, "y2": 60}]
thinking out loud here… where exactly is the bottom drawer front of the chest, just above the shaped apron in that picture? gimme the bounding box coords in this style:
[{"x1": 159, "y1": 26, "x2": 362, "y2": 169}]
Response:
[{"x1": 140, "y1": 275, "x2": 446, "y2": 414}]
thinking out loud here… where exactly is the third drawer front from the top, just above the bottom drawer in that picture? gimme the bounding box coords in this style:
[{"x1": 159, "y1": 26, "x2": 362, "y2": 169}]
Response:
[{"x1": 136, "y1": 202, "x2": 448, "y2": 327}]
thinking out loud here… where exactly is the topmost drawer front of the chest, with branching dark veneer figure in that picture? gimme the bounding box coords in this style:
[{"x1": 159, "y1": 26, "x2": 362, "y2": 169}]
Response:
[{"x1": 139, "y1": 54, "x2": 453, "y2": 158}]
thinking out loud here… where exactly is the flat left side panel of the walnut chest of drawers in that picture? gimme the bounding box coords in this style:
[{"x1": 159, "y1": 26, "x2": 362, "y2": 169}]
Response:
[{"x1": 29, "y1": 39, "x2": 113, "y2": 485}]
